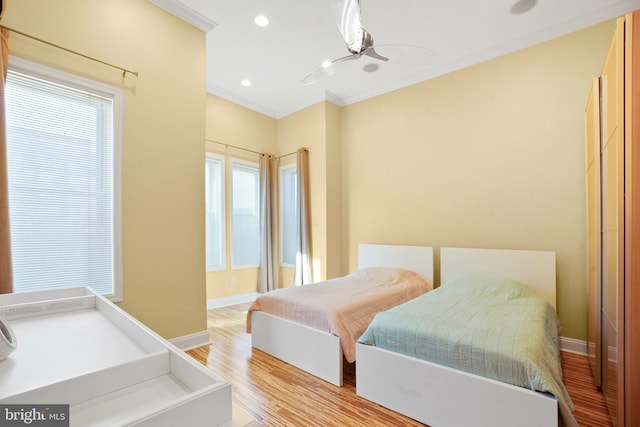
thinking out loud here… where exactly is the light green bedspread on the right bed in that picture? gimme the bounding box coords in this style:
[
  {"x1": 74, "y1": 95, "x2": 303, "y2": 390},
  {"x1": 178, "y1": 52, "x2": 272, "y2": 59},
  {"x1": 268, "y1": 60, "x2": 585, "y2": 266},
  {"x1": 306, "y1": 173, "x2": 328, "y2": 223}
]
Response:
[{"x1": 358, "y1": 278, "x2": 578, "y2": 426}]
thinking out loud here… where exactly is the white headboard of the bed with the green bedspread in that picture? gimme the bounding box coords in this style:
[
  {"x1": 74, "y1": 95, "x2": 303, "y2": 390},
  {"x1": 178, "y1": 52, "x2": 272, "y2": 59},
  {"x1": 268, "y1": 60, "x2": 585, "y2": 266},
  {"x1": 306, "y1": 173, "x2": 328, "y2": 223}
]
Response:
[{"x1": 440, "y1": 248, "x2": 556, "y2": 308}]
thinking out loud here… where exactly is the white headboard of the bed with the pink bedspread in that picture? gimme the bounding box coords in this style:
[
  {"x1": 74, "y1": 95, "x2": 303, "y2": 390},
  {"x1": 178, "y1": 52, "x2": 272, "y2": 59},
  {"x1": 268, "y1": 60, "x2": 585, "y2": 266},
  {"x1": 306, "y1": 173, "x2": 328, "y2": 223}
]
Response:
[{"x1": 358, "y1": 243, "x2": 433, "y2": 284}]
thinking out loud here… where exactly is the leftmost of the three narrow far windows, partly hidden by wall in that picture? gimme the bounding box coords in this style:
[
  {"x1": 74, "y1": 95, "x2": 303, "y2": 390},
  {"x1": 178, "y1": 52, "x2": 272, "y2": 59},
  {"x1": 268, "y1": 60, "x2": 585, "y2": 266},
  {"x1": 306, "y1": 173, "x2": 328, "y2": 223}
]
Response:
[{"x1": 205, "y1": 153, "x2": 227, "y2": 271}]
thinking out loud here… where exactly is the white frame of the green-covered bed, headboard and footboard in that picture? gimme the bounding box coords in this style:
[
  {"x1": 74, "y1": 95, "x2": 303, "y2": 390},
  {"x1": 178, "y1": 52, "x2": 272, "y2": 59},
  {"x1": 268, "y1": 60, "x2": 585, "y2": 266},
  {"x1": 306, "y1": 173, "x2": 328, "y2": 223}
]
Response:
[{"x1": 356, "y1": 248, "x2": 558, "y2": 427}]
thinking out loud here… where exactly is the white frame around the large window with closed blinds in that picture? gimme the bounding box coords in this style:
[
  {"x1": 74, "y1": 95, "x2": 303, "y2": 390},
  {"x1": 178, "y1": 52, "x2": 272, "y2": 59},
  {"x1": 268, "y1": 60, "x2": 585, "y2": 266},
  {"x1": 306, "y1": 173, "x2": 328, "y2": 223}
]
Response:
[{"x1": 8, "y1": 55, "x2": 124, "y2": 302}]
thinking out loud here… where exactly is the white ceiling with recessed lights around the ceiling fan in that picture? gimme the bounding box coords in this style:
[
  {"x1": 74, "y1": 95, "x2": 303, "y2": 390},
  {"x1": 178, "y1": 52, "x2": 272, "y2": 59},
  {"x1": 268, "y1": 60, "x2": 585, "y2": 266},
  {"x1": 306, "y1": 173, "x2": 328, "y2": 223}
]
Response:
[{"x1": 150, "y1": 0, "x2": 640, "y2": 118}]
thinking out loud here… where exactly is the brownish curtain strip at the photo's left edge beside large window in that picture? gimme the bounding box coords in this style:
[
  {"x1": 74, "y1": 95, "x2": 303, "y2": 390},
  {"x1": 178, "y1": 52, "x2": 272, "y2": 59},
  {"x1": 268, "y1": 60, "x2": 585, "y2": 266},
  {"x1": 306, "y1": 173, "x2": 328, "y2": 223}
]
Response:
[{"x1": 0, "y1": 26, "x2": 13, "y2": 294}]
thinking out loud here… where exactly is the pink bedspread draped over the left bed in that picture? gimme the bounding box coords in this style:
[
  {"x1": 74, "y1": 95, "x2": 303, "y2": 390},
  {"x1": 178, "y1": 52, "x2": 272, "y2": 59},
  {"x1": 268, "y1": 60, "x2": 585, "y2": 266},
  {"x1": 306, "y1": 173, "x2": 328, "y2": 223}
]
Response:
[{"x1": 247, "y1": 267, "x2": 433, "y2": 363}]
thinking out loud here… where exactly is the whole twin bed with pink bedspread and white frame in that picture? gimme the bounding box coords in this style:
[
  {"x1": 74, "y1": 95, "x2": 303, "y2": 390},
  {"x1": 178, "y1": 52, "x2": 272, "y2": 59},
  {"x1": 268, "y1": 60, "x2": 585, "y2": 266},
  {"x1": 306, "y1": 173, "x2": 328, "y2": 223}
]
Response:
[{"x1": 247, "y1": 244, "x2": 433, "y2": 386}]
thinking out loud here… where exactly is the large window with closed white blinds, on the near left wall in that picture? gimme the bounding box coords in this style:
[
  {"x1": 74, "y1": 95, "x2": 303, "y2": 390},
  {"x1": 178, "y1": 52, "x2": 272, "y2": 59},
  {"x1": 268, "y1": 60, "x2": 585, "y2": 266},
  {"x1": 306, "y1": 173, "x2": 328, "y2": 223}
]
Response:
[{"x1": 5, "y1": 58, "x2": 122, "y2": 300}]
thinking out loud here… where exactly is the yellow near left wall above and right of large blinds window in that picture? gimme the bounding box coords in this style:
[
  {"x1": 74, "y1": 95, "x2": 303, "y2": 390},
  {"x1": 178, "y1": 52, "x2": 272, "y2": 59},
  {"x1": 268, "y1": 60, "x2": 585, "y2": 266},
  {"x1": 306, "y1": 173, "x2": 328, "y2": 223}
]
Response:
[{"x1": 2, "y1": 0, "x2": 207, "y2": 338}]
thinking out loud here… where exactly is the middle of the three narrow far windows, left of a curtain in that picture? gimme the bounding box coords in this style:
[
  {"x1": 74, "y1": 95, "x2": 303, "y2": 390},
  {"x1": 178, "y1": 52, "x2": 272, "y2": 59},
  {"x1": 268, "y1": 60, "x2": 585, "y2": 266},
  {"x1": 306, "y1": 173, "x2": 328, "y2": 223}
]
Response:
[{"x1": 231, "y1": 160, "x2": 260, "y2": 267}]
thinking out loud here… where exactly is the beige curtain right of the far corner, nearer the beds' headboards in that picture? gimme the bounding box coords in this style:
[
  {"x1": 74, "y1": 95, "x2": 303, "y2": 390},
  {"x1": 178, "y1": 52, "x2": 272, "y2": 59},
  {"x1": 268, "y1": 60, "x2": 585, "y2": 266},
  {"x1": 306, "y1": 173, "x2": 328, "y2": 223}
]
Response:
[{"x1": 293, "y1": 148, "x2": 313, "y2": 286}]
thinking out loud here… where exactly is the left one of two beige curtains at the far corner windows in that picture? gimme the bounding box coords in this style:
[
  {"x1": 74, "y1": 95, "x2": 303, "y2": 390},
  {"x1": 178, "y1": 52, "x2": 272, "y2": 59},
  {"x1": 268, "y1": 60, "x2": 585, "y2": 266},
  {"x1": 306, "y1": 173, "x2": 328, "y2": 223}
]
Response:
[{"x1": 258, "y1": 153, "x2": 278, "y2": 293}]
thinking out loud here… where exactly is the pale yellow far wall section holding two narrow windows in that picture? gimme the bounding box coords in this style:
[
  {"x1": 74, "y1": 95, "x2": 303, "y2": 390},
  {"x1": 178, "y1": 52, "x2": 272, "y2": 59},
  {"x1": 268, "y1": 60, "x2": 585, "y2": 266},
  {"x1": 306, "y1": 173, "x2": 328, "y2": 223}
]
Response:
[{"x1": 203, "y1": 95, "x2": 277, "y2": 299}]
